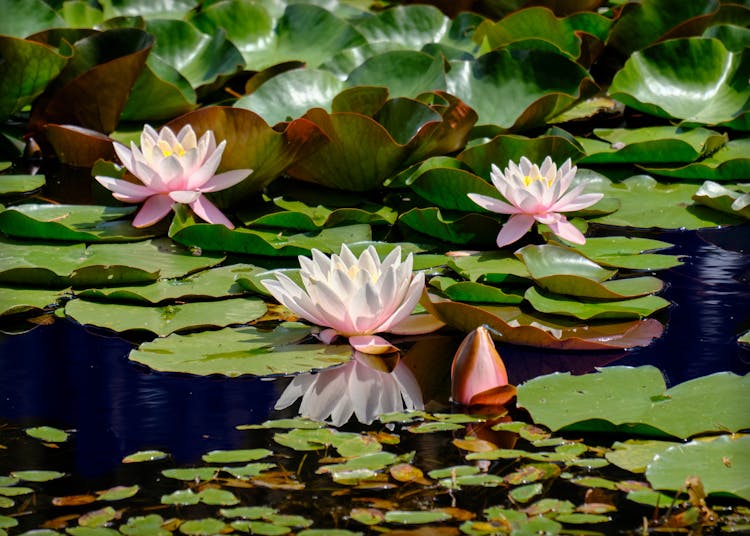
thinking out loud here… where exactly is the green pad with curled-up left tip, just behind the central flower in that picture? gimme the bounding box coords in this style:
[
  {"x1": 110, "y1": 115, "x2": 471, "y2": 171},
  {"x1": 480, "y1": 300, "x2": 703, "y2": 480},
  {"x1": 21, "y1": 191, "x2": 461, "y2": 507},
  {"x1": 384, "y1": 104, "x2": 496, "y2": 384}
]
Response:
[{"x1": 169, "y1": 205, "x2": 372, "y2": 256}]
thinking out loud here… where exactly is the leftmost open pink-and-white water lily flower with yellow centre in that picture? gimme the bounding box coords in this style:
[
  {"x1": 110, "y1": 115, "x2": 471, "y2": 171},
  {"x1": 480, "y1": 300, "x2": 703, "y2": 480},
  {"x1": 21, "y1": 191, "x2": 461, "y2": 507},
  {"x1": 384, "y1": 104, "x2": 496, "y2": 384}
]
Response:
[{"x1": 96, "y1": 125, "x2": 252, "y2": 229}]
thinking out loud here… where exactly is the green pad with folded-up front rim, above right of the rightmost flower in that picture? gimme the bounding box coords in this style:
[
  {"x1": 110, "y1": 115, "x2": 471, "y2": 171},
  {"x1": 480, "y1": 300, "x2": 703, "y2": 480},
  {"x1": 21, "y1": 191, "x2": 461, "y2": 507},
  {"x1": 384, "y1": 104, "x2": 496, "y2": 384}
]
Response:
[{"x1": 576, "y1": 126, "x2": 727, "y2": 165}]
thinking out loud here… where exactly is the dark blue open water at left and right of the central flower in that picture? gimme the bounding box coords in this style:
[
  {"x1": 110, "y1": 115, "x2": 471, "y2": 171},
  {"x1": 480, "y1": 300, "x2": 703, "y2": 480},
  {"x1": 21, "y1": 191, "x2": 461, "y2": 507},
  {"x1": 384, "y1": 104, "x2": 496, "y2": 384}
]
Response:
[{"x1": 0, "y1": 226, "x2": 750, "y2": 476}]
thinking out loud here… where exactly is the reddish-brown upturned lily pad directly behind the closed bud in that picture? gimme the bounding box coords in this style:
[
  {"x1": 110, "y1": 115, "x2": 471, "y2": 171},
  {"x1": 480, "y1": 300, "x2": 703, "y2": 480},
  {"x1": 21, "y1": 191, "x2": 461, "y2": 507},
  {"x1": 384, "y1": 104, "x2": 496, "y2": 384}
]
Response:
[{"x1": 423, "y1": 301, "x2": 664, "y2": 350}]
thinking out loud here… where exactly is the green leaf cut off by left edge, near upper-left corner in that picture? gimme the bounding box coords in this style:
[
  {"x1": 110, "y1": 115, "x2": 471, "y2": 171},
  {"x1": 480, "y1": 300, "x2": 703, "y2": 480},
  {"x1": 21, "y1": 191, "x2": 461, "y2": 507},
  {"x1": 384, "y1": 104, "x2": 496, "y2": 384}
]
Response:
[{"x1": 0, "y1": 36, "x2": 68, "y2": 120}]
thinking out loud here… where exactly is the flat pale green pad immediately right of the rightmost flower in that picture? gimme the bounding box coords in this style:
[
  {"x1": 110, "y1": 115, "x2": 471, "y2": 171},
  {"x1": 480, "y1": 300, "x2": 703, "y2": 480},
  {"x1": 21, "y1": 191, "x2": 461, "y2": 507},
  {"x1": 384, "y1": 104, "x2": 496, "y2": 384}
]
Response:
[{"x1": 578, "y1": 171, "x2": 743, "y2": 229}]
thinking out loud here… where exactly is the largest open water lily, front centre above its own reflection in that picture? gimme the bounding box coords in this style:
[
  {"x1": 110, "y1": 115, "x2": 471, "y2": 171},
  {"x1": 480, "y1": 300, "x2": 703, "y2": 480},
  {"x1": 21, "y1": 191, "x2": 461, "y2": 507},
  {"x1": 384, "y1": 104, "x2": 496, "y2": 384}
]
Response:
[{"x1": 262, "y1": 245, "x2": 443, "y2": 354}]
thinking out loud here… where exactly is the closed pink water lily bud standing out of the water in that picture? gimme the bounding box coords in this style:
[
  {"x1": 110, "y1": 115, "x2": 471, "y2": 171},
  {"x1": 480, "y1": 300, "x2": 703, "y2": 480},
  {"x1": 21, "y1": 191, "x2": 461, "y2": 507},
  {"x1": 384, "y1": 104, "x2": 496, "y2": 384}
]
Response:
[{"x1": 451, "y1": 326, "x2": 515, "y2": 406}]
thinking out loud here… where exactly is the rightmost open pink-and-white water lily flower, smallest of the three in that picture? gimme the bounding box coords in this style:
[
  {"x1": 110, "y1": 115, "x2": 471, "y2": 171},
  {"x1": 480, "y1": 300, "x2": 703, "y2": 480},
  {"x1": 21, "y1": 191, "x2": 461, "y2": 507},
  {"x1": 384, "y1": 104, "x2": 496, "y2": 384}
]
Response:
[{"x1": 468, "y1": 156, "x2": 604, "y2": 247}]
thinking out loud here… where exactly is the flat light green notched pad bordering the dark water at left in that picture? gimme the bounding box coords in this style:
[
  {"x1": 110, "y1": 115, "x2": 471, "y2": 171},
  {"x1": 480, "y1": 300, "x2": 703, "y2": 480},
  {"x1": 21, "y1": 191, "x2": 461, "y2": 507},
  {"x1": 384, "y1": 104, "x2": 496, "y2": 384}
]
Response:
[{"x1": 65, "y1": 297, "x2": 266, "y2": 337}]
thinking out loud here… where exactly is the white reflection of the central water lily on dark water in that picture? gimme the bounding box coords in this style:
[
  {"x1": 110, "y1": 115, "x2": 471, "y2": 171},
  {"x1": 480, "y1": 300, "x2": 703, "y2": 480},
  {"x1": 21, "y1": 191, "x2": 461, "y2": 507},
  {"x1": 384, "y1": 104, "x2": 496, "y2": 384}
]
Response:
[{"x1": 275, "y1": 351, "x2": 424, "y2": 426}]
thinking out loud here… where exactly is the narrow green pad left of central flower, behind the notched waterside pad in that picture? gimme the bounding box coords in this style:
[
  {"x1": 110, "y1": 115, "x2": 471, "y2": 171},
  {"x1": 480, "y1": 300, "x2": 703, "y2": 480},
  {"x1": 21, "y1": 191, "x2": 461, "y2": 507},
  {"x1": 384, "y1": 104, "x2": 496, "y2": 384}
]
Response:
[{"x1": 76, "y1": 264, "x2": 258, "y2": 304}]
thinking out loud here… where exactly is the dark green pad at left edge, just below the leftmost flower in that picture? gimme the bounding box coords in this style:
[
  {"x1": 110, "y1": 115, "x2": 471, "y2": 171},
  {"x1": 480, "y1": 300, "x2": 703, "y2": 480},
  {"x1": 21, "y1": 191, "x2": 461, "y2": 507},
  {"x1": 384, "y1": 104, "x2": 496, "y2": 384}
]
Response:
[{"x1": 0, "y1": 204, "x2": 161, "y2": 243}]
